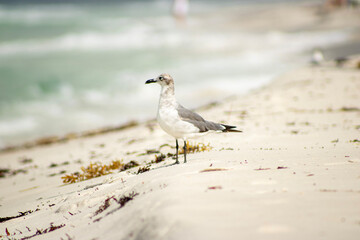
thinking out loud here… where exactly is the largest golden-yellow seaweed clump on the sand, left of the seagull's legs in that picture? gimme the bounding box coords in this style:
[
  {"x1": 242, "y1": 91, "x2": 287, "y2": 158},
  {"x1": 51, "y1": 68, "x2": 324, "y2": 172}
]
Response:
[{"x1": 61, "y1": 160, "x2": 139, "y2": 183}]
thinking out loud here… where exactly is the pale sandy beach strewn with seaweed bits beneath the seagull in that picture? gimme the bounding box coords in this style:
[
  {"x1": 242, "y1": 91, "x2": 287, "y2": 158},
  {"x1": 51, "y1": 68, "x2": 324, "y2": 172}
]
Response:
[{"x1": 0, "y1": 1, "x2": 360, "y2": 239}]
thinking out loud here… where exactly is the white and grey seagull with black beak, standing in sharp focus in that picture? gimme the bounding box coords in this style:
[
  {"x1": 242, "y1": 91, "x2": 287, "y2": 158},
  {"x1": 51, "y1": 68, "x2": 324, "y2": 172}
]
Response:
[{"x1": 145, "y1": 73, "x2": 242, "y2": 164}]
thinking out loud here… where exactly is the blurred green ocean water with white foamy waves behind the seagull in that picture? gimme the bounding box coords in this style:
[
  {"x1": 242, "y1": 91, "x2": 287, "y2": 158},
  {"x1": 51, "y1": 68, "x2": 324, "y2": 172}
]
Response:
[{"x1": 0, "y1": 0, "x2": 348, "y2": 148}]
